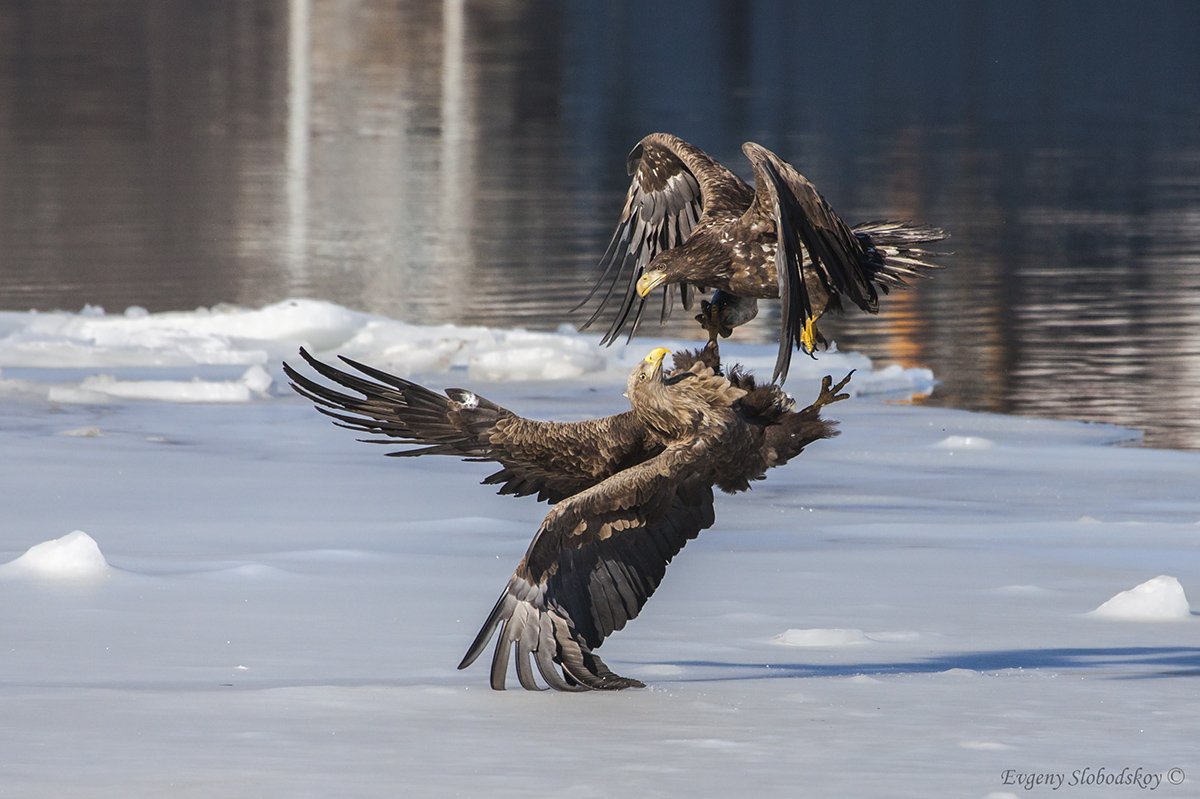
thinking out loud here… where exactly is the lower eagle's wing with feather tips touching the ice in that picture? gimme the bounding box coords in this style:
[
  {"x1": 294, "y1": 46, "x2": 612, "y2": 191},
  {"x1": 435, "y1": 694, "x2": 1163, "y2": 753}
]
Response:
[{"x1": 458, "y1": 447, "x2": 714, "y2": 690}]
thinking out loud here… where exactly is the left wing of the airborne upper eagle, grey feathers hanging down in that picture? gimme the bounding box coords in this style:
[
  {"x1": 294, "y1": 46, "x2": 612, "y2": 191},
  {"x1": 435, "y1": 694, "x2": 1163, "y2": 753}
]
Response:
[{"x1": 576, "y1": 133, "x2": 752, "y2": 344}]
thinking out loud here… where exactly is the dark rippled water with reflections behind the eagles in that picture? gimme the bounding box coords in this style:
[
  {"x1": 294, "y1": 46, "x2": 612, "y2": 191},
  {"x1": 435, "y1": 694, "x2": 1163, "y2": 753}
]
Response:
[{"x1": 0, "y1": 0, "x2": 1200, "y2": 447}]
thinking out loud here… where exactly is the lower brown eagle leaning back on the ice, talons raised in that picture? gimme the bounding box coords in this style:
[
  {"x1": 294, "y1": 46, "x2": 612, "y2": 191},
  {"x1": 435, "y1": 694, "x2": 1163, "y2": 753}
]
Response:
[{"x1": 284, "y1": 344, "x2": 850, "y2": 690}]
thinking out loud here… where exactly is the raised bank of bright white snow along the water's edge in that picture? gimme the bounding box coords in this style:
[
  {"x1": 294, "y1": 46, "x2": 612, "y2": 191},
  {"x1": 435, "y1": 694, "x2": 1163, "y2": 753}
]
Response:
[{"x1": 0, "y1": 299, "x2": 934, "y2": 403}]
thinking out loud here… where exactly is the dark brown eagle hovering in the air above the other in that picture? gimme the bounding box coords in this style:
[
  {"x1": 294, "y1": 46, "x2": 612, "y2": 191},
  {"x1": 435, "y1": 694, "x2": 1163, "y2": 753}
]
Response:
[{"x1": 580, "y1": 133, "x2": 947, "y2": 382}]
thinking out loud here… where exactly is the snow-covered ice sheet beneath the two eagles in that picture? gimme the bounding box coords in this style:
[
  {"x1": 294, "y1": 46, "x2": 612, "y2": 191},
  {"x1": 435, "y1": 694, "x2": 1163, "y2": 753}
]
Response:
[{"x1": 0, "y1": 301, "x2": 1200, "y2": 799}]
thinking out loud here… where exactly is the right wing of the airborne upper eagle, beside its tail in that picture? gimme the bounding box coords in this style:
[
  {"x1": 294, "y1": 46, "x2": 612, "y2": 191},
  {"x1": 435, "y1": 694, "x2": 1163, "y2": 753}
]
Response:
[{"x1": 742, "y1": 142, "x2": 882, "y2": 379}]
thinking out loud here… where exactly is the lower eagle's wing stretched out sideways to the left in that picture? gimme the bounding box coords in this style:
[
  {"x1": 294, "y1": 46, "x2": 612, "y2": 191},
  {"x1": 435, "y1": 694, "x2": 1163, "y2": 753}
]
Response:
[{"x1": 283, "y1": 349, "x2": 662, "y2": 503}]
